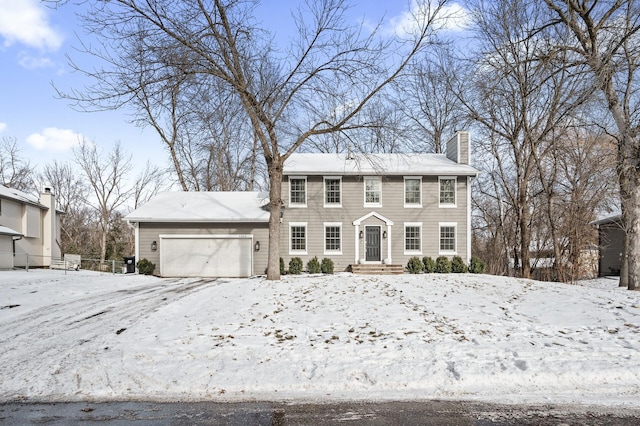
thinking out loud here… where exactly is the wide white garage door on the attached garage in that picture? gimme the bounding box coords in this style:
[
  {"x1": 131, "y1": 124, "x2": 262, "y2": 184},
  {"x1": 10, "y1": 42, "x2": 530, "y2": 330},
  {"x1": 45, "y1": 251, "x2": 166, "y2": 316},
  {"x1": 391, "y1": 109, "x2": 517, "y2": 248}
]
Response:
[{"x1": 160, "y1": 235, "x2": 253, "y2": 277}]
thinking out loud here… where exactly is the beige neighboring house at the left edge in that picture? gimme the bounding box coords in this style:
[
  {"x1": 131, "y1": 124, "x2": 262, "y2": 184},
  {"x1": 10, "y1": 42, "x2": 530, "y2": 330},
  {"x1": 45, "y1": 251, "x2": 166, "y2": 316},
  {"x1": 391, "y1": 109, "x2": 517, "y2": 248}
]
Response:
[{"x1": 0, "y1": 185, "x2": 61, "y2": 269}]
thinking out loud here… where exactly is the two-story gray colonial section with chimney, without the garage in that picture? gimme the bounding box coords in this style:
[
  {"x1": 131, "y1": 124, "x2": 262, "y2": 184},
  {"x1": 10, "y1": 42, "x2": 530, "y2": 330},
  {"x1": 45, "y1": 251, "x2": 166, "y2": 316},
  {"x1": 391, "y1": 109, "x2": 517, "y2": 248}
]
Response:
[{"x1": 280, "y1": 132, "x2": 478, "y2": 270}]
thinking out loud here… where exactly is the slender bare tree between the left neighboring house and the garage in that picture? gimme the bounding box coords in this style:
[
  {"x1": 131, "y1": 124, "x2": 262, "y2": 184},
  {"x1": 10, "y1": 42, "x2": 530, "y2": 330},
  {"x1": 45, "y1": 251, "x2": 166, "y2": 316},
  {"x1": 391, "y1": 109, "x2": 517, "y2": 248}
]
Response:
[{"x1": 73, "y1": 140, "x2": 132, "y2": 262}]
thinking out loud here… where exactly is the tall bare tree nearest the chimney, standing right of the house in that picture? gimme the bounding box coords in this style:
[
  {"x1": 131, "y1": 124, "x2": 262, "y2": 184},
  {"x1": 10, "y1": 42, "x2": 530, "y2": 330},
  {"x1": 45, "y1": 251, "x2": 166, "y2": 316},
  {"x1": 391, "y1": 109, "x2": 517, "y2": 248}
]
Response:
[{"x1": 456, "y1": 0, "x2": 587, "y2": 278}]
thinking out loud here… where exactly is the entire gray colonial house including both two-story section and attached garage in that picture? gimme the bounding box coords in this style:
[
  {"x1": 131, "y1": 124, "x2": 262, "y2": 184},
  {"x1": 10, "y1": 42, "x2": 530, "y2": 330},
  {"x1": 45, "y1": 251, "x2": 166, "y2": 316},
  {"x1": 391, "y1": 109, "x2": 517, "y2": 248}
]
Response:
[{"x1": 126, "y1": 132, "x2": 479, "y2": 276}]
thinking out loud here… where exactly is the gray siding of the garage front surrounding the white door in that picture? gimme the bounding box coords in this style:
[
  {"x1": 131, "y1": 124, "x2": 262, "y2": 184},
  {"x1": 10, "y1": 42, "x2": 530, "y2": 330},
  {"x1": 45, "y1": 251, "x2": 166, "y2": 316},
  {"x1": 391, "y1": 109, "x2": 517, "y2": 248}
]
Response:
[{"x1": 136, "y1": 222, "x2": 269, "y2": 275}]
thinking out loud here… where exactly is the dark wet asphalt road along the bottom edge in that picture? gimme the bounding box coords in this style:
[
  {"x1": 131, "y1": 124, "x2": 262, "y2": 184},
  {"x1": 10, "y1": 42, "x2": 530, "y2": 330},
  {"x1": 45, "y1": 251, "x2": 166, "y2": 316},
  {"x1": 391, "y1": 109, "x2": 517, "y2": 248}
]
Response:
[{"x1": 0, "y1": 401, "x2": 640, "y2": 426}]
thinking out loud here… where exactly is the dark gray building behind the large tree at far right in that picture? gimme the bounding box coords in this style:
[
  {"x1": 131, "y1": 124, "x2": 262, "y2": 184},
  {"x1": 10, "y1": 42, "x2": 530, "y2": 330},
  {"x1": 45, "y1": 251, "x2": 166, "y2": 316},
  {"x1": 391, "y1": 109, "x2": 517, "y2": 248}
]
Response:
[{"x1": 591, "y1": 214, "x2": 624, "y2": 277}]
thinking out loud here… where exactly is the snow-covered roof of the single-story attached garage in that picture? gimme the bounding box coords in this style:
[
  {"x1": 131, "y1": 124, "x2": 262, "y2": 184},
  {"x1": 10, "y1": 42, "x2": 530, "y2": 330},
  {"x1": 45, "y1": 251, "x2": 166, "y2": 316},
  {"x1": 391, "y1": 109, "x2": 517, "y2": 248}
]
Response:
[{"x1": 125, "y1": 192, "x2": 269, "y2": 222}]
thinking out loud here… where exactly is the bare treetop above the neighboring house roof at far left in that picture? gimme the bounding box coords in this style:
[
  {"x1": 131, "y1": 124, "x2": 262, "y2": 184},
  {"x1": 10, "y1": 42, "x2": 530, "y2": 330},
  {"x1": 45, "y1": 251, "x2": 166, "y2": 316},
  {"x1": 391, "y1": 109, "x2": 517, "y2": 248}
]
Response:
[{"x1": 0, "y1": 137, "x2": 35, "y2": 192}]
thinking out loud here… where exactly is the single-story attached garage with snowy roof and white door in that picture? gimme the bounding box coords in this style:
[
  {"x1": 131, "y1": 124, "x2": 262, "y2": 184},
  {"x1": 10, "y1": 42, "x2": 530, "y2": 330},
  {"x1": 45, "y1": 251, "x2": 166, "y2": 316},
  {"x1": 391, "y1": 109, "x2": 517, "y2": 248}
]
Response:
[{"x1": 126, "y1": 192, "x2": 269, "y2": 278}]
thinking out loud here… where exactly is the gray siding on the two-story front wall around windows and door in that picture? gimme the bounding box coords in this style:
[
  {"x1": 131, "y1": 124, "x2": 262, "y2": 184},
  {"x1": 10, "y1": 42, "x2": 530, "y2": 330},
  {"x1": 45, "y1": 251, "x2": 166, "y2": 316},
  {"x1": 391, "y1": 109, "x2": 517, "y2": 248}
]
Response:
[{"x1": 280, "y1": 176, "x2": 468, "y2": 271}]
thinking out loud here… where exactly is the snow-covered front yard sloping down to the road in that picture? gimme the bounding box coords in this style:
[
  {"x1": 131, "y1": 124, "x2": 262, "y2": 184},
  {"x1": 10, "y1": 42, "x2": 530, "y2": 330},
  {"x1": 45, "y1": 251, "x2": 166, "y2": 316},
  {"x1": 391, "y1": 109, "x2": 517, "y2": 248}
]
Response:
[{"x1": 0, "y1": 270, "x2": 640, "y2": 407}]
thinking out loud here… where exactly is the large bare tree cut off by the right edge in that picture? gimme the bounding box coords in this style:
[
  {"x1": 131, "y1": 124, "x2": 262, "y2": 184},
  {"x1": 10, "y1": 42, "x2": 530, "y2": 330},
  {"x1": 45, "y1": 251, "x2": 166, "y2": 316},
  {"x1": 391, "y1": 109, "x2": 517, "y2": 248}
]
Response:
[{"x1": 545, "y1": 0, "x2": 640, "y2": 290}]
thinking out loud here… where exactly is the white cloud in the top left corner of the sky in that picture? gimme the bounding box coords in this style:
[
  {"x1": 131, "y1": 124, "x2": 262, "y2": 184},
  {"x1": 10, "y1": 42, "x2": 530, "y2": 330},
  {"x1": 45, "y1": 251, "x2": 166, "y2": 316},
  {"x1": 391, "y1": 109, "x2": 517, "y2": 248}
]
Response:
[{"x1": 0, "y1": 0, "x2": 63, "y2": 50}]
